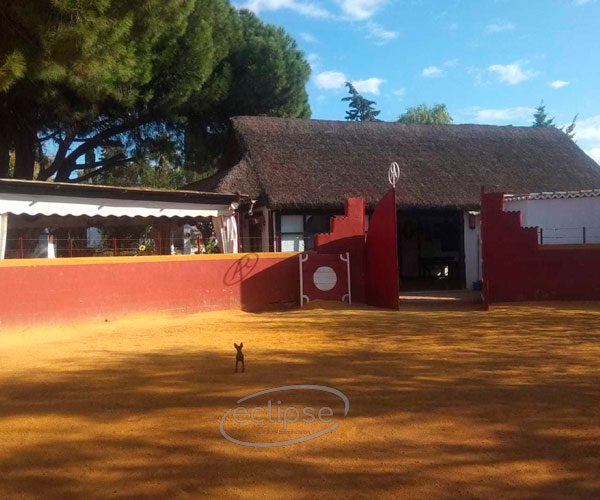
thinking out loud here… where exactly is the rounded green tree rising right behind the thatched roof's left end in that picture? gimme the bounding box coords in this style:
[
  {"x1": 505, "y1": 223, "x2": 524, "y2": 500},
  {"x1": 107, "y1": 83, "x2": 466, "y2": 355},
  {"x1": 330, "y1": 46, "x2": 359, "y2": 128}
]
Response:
[{"x1": 185, "y1": 9, "x2": 311, "y2": 169}]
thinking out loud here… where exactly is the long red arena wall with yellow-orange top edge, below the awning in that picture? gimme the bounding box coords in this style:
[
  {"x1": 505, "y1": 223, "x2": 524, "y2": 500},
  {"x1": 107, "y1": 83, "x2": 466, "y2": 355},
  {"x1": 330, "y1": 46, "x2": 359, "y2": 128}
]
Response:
[{"x1": 0, "y1": 253, "x2": 300, "y2": 327}]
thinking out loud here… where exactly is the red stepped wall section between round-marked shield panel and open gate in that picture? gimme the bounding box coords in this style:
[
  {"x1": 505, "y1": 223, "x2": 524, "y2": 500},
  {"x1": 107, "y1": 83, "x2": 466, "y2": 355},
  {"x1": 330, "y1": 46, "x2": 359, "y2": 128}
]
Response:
[{"x1": 314, "y1": 198, "x2": 366, "y2": 302}]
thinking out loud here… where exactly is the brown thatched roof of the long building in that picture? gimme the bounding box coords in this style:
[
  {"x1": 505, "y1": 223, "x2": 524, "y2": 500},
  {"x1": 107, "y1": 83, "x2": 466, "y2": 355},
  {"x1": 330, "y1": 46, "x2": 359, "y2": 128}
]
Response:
[{"x1": 188, "y1": 116, "x2": 600, "y2": 209}]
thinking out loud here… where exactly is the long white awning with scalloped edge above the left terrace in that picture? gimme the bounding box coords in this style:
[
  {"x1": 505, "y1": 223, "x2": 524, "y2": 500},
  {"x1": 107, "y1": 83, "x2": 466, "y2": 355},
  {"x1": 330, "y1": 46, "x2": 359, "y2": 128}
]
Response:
[{"x1": 0, "y1": 193, "x2": 229, "y2": 217}]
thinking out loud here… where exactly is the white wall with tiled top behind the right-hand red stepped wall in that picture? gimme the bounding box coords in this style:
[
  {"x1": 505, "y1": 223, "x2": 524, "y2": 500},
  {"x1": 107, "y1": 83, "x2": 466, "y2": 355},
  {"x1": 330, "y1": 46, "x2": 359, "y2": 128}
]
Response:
[{"x1": 504, "y1": 196, "x2": 600, "y2": 245}]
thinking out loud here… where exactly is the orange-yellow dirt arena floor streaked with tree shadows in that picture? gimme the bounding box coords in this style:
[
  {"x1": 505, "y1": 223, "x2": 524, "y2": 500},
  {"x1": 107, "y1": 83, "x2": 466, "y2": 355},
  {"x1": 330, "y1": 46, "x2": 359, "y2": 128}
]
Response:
[{"x1": 0, "y1": 303, "x2": 600, "y2": 500}]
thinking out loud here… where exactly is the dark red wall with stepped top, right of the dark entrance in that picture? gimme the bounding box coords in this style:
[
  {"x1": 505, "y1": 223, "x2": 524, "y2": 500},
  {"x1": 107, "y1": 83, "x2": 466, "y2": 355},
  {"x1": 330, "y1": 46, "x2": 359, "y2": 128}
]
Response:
[{"x1": 481, "y1": 192, "x2": 600, "y2": 305}]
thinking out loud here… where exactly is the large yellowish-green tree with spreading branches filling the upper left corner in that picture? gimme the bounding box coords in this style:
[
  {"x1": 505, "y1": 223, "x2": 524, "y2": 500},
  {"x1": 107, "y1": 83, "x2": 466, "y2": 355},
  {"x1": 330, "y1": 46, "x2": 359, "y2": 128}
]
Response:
[{"x1": 0, "y1": 0, "x2": 203, "y2": 180}]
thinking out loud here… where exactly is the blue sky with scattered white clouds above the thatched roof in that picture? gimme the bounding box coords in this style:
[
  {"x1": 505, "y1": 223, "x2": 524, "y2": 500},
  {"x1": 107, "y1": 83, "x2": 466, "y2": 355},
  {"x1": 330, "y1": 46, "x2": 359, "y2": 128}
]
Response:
[{"x1": 236, "y1": 0, "x2": 600, "y2": 162}]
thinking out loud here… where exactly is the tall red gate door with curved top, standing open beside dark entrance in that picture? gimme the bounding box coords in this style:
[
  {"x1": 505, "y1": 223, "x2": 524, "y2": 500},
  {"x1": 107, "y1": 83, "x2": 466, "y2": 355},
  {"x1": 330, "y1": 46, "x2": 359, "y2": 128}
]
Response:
[{"x1": 366, "y1": 188, "x2": 400, "y2": 310}]
